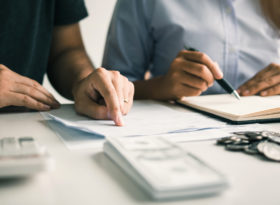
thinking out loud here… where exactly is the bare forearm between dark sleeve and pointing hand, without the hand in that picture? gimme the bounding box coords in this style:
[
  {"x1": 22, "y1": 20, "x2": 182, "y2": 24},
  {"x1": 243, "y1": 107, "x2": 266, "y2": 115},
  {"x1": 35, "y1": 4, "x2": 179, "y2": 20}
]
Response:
[{"x1": 47, "y1": 24, "x2": 91, "y2": 100}]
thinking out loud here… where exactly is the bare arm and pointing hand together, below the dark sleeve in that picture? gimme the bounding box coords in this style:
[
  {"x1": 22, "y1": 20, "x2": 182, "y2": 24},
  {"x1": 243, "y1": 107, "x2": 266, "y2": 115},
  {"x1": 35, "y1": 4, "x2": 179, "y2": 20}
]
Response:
[{"x1": 47, "y1": 23, "x2": 134, "y2": 125}]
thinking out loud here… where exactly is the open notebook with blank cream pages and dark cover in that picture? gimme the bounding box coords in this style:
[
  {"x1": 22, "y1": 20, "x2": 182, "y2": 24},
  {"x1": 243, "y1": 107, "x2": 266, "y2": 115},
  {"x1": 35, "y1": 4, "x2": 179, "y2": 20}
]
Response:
[{"x1": 177, "y1": 94, "x2": 280, "y2": 124}]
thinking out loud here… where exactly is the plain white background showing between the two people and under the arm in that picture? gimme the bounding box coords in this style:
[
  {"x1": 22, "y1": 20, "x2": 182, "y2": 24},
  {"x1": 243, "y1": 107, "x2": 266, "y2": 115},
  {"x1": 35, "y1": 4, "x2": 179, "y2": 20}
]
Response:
[{"x1": 43, "y1": 0, "x2": 116, "y2": 103}]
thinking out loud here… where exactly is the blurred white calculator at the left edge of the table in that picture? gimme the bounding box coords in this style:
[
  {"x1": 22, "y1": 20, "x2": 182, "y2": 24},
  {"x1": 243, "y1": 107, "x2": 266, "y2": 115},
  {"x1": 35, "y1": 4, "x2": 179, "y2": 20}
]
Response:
[{"x1": 0, "y1": 137, "x2": 54, "y2": 178}]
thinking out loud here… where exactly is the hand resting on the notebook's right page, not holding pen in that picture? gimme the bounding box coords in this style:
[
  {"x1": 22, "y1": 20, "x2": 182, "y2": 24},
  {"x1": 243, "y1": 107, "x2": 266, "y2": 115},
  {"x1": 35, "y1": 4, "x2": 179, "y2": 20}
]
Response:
[{"x1": 237, "y1": 63, "x2": 280, "y2": 96}]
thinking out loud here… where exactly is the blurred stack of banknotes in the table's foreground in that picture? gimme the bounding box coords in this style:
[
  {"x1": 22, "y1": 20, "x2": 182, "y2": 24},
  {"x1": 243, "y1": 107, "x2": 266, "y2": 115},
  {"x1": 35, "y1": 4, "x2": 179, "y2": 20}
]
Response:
[{"x1": 104, "y1": 137, "x2": 227, "y2": 199}]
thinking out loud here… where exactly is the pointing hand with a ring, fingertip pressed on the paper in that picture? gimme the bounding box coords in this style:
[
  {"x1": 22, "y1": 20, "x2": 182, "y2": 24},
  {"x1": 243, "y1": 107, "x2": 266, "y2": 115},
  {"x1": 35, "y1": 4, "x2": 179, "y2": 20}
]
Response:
[{"x1": 73, "y1": 68, "x2": 134, "y2": 126}]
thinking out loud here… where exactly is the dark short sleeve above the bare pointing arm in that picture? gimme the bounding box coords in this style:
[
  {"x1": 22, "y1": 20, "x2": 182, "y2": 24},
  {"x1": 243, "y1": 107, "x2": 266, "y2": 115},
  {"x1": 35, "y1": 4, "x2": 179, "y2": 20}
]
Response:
[{"x1": 54, "y1": 0, "x2": 88, "y2": 26}]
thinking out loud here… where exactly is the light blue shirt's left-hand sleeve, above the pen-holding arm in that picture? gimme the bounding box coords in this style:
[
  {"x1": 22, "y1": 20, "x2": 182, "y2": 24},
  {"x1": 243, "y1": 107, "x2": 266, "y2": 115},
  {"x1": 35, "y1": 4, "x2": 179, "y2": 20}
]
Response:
[{"x1": 102, "y1": 0, "x2": 153, "y2": 81}]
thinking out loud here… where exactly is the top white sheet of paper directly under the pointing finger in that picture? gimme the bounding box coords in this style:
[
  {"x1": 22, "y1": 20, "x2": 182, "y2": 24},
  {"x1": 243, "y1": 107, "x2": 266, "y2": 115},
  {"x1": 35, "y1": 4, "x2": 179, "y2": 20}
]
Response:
[{"x1": 44, "y1": 101, "x2": 226, "y2": 136}]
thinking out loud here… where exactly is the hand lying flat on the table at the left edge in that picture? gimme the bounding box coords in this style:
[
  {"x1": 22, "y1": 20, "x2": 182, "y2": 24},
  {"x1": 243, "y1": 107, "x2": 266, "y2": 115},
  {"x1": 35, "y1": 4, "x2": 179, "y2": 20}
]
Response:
[{"x1": 0, "y1": 65, "x2": 60, "y2": 111}]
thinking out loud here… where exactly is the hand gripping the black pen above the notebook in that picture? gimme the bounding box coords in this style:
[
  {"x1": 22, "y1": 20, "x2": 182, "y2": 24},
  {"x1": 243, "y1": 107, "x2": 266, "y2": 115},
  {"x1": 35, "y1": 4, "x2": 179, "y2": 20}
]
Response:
[{"x1": 158, "y1": 50, "x2": 223, "y2": 100}]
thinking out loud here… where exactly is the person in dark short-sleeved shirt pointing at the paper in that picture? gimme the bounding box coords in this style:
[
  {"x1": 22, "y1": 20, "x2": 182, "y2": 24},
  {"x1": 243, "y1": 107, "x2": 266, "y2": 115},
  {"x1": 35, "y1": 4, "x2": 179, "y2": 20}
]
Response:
[{"x1": 0, "y1": 0, "x2": 134, "y2": 125}]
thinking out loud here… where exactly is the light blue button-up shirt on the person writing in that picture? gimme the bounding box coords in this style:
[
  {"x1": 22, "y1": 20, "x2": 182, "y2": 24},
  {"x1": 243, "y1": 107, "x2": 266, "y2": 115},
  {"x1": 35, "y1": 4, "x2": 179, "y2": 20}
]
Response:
[{"x1": 103, "y1": 0, "x2": 280, "y2": 94}]
